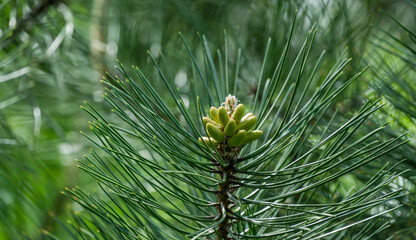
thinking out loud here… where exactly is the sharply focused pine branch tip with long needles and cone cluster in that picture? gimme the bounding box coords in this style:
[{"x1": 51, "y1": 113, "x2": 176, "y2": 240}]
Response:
[{"x1": 65, "y1": 16, "x2": 405, "y2": 239}]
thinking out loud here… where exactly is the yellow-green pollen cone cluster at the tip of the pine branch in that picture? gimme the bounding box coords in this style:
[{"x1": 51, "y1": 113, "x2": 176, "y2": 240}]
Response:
[{"x1": 199, "y1": 95, "x2": 263, "y2": 147}]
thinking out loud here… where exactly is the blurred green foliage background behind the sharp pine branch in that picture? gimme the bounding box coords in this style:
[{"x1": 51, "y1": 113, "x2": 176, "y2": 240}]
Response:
[{"x1": 0, "y1": 0, "x2": 416, "y2": 239}]
